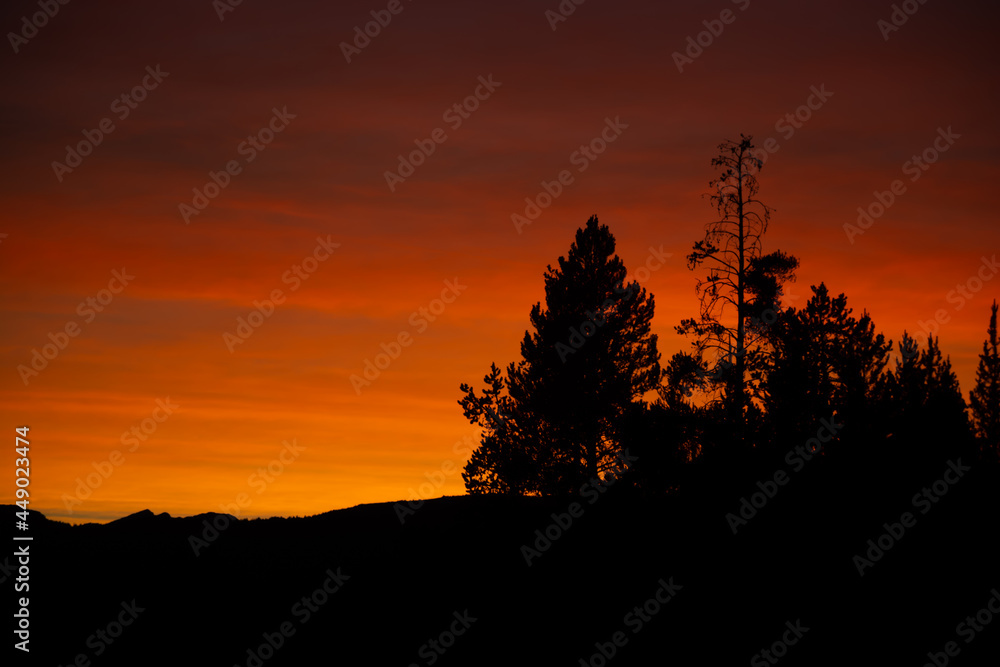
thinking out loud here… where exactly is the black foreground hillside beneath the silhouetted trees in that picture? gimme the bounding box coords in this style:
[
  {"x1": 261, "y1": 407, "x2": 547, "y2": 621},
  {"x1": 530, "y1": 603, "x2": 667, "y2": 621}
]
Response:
[{"x1": 0, "y1": 459, "x2": 1000, "y2": 667}]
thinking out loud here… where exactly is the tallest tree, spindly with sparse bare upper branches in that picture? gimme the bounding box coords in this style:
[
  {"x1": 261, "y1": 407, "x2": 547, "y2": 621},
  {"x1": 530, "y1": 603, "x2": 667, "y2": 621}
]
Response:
[{"x1": 677, "y1": 134, "x2": 799, "y2": 448}]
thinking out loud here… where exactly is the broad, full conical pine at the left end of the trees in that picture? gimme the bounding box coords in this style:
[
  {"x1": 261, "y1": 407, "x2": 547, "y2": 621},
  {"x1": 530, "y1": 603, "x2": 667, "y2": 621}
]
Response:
[{"x1": 459, "y1": 216, "x2": 661, "y2": 494}]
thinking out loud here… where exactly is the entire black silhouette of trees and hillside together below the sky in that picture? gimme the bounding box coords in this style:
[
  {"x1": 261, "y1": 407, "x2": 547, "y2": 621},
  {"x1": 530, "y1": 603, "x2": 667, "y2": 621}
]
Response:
[{"x1": 9, "y1": 137, "x2": 1000, "y2": 667}]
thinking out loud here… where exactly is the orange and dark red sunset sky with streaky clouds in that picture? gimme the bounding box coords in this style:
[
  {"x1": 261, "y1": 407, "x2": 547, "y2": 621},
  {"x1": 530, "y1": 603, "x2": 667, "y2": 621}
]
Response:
[{"x1": 0, "y1": 0, "x2": 1000, "y2": 523}]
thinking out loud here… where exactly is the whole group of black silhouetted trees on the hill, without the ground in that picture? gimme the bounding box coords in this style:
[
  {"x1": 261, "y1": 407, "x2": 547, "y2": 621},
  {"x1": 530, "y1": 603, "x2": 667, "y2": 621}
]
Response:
[{"x1": 459, "y1": 135, "x2": 1000, "y2": 495}]
